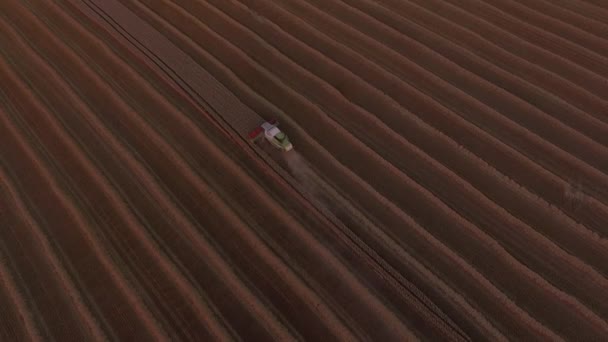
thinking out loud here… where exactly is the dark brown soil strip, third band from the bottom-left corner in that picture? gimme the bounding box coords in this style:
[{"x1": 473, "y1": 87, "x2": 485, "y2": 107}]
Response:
[{"x1": 1, "y1": 69, "x2": 164, "y2": 338}]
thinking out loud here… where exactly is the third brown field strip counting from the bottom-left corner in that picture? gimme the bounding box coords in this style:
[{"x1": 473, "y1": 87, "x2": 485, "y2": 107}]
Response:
[{"x1": 0, "y1": 70, "x2": 166, "y2": 340}]
